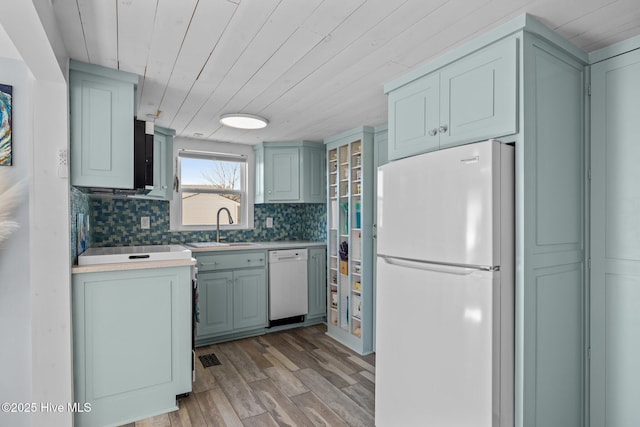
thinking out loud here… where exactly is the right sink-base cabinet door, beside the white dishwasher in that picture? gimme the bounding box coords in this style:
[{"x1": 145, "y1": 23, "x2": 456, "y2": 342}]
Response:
[{"x1": 233, "y1": 269, "x2": 267, "y2": 329}]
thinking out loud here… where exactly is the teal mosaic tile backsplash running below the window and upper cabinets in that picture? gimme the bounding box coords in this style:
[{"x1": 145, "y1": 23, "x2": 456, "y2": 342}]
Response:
[{"x1": 82, "y1": 198, "x2": 326, "y2": 251}]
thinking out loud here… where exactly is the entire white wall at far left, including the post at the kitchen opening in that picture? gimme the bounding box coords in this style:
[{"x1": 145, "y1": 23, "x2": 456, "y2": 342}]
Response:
[{"x1": 0, "y1": 0, "x2": 73, "y2": 427}]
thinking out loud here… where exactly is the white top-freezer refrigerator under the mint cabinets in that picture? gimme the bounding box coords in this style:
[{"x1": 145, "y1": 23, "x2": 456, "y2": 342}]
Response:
[{"x1": 375, "y1": 140, "x2": 514, "y2": 427}]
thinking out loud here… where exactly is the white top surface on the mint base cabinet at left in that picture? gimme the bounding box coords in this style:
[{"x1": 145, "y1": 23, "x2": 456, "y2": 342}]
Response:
[{"x1": 78, "y1": 245, "x2": 191, "y2": 265}]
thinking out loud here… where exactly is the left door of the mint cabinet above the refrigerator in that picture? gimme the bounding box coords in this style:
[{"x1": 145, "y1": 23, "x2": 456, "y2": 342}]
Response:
[{"x1": 389, "y1": 73, "x2": 440, "y2": 160}]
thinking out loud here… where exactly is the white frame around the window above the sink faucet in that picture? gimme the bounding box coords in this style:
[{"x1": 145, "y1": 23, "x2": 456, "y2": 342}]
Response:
[{"x1": 169, "y1": 138, "x2": 255, "y2": 231}]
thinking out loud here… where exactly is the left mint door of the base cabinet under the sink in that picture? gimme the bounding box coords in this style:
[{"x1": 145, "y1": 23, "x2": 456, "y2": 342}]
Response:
[{"x1": 196, "y1": 271, "x2": 233, "y2": 338}]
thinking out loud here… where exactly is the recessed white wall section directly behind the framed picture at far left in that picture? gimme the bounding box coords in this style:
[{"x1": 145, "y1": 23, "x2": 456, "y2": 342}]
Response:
[{"x1": 0, "y1": 58, "x2": 33, "y2": 426}]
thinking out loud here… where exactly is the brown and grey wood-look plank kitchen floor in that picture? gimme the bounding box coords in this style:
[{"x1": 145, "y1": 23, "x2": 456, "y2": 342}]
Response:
[{"x1": 120, "y1": 325, "x2": 375, "y2": 427}]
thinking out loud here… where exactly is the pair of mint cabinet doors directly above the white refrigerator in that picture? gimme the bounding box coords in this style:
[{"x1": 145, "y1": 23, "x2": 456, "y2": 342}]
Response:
[{"x1": 389, "y1": 38, "x2": 517, "y2": 160}]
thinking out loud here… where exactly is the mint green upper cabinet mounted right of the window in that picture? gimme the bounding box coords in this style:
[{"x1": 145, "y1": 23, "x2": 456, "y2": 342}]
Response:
[{"x1": 254, "y1": 141, "x2": 325, "y2": 203}]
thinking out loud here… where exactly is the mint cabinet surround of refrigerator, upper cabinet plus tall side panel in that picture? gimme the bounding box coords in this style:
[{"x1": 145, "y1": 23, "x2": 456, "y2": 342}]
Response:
[{"x1": 377, "y1": 15, "x2": 588, "y2": 427}]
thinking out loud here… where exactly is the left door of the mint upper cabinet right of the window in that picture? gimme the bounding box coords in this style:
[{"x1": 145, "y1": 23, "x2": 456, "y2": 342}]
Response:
[{"x1": 264, "y1": 147, "x2": 300, "y2": 202}]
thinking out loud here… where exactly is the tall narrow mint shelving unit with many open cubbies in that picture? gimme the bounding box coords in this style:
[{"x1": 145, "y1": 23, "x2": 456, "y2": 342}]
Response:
[{"x1": 325, "y1": 127, "x2": 375, "y2": 354}]
